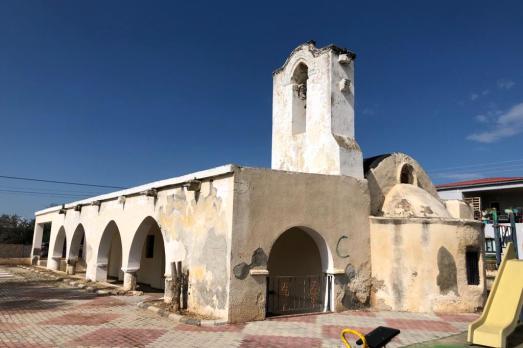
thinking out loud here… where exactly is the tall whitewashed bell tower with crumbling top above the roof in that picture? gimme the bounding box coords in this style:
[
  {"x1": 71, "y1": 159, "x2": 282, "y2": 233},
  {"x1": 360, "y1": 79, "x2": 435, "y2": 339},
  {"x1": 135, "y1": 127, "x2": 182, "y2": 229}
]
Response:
[{"x1": 272, "y1": 41, "x2": 363, "y2": 179}]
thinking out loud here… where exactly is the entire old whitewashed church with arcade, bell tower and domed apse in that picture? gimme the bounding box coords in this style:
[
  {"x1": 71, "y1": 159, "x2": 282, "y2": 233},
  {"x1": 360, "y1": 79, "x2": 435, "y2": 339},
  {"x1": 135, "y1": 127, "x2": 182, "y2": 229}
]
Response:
[{"x1": 32, "y1": 42, "x2": 485, "y2": 323}]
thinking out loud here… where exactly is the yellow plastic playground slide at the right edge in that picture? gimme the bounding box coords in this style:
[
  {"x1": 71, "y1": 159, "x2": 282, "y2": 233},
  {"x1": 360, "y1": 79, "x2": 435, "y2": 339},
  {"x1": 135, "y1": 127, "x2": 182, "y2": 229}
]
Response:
[{"x1": 467, "y1": 243, "x2": 523, "y2": 347}]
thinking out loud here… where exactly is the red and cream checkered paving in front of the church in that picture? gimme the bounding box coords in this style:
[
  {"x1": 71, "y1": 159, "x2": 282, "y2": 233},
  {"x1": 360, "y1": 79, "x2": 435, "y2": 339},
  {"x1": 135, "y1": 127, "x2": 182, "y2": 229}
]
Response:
[{"x1": 0, "y1": 266, "x2": 477, "y2": 348}]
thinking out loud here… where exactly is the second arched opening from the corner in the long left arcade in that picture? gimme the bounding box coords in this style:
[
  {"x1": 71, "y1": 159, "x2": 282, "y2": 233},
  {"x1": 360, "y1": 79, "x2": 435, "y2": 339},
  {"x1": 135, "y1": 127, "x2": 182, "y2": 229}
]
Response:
[{"x1": 96, "y1": 221, "x2": 123, "y2": 283}]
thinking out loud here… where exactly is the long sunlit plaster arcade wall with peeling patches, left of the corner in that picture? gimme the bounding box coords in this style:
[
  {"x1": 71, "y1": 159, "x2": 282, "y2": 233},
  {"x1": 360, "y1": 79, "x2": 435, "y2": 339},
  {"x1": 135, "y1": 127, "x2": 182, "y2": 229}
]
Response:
[{"x1": 33, "y1": 168, "x2": 233, "y2": 318}]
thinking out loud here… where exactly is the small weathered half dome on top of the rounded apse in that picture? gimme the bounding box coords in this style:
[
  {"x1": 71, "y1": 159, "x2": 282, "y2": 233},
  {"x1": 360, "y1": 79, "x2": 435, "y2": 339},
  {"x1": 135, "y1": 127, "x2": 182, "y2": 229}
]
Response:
[{"x1": 382, "y1": 184, "x2": 451, "y2": 218}]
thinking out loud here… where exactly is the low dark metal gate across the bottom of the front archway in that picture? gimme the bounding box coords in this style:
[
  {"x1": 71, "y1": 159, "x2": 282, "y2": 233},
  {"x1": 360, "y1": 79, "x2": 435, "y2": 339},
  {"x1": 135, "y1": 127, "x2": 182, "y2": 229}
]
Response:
[{"x1": 267, "y1": 274, "x2": 326, "y2": 316}]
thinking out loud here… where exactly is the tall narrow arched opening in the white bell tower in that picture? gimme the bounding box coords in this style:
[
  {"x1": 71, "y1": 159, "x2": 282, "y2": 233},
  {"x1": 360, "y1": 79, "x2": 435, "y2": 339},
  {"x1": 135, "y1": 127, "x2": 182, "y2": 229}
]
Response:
[{"x1": 291, "y1": 63, "x2": 309, "y2": 134}]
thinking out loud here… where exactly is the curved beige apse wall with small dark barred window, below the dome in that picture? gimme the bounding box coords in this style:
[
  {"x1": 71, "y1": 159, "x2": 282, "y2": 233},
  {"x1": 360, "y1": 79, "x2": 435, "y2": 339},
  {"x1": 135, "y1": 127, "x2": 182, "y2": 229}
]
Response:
[{"x1": 370, "y1": 217, "x2": 485, "y2": 313}]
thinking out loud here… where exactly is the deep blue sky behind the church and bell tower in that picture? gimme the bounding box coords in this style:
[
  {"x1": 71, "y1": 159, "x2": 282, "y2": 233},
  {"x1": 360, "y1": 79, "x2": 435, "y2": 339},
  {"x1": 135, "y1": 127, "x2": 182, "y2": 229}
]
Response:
[{"x1": 0, "y1": 0, "x2": 523, "y2": 216}]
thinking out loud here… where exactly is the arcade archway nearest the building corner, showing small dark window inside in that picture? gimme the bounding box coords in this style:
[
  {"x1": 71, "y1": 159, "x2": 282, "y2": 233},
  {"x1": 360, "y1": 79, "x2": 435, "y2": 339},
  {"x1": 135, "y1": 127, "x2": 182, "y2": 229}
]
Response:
[{"x1": 128, "y1": 217, "x2": 165, "y2": 291}]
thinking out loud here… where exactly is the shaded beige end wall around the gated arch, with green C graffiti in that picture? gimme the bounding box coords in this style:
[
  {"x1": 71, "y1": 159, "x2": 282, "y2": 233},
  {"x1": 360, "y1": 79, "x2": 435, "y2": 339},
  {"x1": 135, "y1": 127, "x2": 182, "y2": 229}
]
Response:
[{"x1": 229, "y1": 168, "x2": 371, "y2": 322}]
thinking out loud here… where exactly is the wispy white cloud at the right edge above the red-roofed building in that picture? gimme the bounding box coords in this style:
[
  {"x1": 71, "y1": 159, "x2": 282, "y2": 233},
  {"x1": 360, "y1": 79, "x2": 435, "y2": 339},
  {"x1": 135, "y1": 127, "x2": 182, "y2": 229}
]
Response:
[{"x1": 467, "y1": 103, "x2": 523, "y2": 144}]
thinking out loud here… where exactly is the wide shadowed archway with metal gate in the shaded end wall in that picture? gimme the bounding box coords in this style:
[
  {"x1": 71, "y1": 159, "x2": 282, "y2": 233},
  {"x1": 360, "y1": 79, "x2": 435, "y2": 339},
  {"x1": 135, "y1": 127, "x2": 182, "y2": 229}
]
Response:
[{"x1": 267, "y1": 227, "x2": 332, "y2": 316}]
